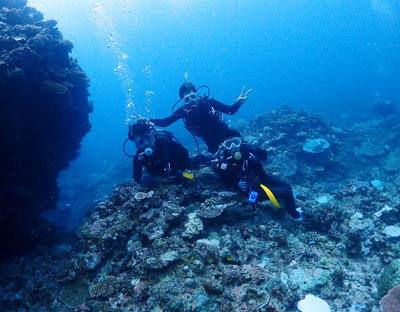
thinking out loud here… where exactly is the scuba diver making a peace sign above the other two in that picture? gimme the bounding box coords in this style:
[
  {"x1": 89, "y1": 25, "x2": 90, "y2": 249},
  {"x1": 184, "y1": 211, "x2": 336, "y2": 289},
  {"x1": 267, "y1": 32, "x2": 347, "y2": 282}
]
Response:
[{"x1": 150, "y1": 82, "x2": 253, "y2": 154}]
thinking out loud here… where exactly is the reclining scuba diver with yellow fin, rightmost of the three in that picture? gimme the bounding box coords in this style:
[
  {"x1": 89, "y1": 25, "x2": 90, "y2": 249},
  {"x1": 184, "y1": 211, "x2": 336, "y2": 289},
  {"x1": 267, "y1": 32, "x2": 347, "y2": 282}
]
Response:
[{"x1": 214, "y1": 137, "x2": 303, "y2": 221}]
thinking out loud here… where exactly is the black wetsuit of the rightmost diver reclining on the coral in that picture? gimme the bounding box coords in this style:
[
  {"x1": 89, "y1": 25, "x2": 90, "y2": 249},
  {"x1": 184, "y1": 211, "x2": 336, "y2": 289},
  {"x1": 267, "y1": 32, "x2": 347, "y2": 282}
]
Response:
[{"x1": 214, "y1": 144, "x2": 299, "y2": 218}]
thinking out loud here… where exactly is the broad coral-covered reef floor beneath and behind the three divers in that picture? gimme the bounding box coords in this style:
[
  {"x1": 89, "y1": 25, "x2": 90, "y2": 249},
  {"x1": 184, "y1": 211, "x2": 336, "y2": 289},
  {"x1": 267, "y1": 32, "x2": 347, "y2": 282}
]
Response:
[{"x1": 0, "y1": 107, "x2": 400, "y2": 312}]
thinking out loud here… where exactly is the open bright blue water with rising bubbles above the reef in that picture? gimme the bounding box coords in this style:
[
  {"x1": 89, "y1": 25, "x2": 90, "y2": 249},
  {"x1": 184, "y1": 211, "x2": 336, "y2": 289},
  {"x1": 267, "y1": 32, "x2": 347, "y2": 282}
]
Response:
[{"x1": 28, "y1": 0, "x2": 400, "y2": 222}]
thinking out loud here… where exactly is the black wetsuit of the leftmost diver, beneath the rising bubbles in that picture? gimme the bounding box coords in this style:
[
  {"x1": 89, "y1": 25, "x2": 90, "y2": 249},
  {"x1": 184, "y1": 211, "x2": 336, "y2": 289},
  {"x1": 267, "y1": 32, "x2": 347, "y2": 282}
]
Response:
[{"x1": 133, "y1": 133, "x2": 191, "y2": 183}]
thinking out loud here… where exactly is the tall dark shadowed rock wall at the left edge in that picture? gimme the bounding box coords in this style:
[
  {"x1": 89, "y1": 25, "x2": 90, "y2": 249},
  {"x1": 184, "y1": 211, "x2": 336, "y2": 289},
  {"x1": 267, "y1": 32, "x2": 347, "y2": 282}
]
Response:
[{"x1": 0, "y1": 0, "x2": 92, "y2": 253}]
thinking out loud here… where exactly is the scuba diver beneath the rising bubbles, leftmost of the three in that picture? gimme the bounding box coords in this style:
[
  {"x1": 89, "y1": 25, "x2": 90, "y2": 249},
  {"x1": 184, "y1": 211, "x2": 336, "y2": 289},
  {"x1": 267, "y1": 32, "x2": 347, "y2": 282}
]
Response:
[{"x1": 124, "y1": 120, "x2": 194, "y2": 187}]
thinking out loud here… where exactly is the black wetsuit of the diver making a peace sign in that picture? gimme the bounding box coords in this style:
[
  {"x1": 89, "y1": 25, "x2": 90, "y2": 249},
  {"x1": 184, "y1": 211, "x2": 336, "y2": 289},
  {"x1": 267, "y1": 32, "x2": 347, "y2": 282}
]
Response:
[{"x1": 150, "y1": 96, "x2": 240, "y2": 154}]
